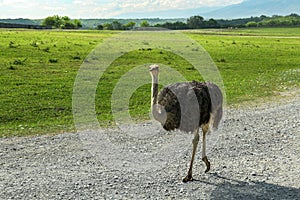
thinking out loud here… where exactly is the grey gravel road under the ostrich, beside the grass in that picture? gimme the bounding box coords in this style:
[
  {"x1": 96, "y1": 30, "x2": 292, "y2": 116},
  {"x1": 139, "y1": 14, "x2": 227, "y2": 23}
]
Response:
[{"x1": 0, "y1": 95, "x2": 300, "y2": 199}]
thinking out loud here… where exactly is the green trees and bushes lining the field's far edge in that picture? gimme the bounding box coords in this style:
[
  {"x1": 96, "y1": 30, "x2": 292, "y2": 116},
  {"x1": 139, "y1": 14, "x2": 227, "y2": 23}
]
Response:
[{"x1": 26, "y1": 14, "x2": 300, "y2": 30}]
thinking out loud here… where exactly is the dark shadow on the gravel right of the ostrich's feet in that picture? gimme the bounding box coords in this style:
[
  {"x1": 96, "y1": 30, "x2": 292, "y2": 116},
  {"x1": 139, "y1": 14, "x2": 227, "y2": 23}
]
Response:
[{"x1": 196, "y1": 173, "x2": 300, "y2": 200}]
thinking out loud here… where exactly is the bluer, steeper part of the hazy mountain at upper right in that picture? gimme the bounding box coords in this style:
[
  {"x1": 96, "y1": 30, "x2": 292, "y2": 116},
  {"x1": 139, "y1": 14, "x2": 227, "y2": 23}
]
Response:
[{"x1": 202, "y1": 0, "x2": 300, "y2": 19}]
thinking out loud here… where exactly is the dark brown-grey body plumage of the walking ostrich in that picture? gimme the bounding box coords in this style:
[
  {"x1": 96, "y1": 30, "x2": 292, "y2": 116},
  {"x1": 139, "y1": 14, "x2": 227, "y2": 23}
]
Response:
[{"x1": 157, "y1": 81, "x2": 221, "y2": 132}]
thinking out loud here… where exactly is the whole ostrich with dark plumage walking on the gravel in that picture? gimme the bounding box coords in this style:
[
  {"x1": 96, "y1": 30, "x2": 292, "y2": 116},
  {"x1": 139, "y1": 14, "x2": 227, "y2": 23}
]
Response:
[{"x1": 149, "y1": 65, "x2": 223, "y2": 182}]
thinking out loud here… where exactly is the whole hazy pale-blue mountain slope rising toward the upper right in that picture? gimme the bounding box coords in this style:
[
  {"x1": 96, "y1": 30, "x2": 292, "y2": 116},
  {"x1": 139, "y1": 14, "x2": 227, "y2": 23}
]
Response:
[{"x1": 116, "y1": 0, "x2": 300, "y2": 19}]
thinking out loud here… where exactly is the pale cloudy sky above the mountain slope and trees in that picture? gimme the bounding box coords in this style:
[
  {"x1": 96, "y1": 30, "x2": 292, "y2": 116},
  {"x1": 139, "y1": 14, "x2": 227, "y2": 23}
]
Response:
[{"x1": 0, "y1": 0, "x2": 243, "y2": 19}]
